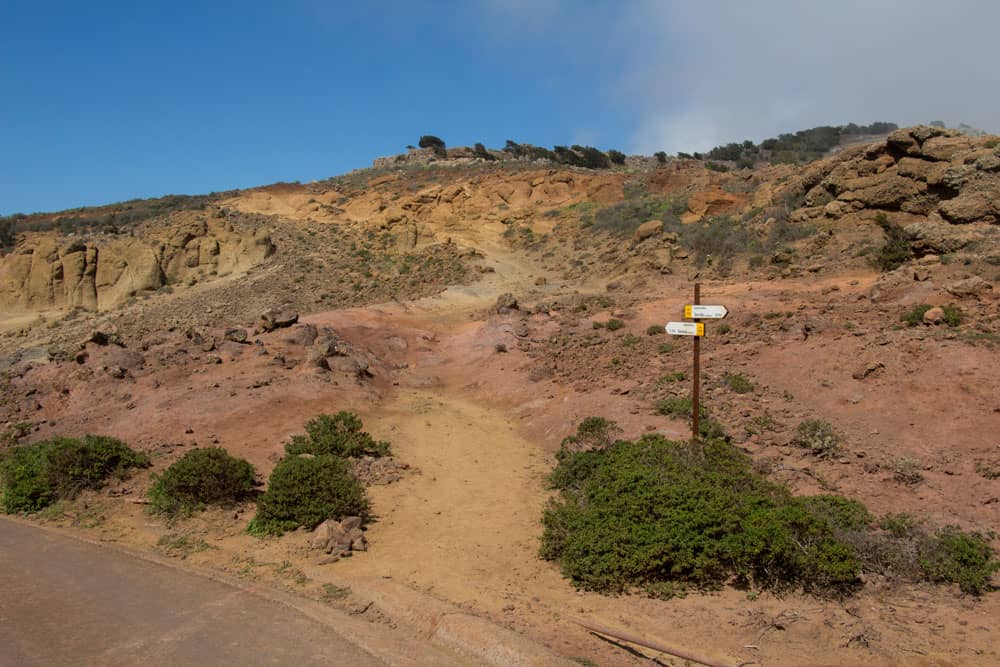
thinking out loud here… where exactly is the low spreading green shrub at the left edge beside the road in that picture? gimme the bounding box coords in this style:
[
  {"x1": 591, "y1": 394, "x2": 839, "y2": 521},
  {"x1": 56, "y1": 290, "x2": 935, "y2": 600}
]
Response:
[{"x1": 0, "y1": 435, "x2": 149, "y2": 514}]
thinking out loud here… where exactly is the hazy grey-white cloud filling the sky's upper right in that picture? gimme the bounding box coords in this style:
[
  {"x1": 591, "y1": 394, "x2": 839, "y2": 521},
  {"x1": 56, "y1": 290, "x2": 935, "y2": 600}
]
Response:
[{"x1": 474, "y1": 0, "x2": 1000, "y2": 153}]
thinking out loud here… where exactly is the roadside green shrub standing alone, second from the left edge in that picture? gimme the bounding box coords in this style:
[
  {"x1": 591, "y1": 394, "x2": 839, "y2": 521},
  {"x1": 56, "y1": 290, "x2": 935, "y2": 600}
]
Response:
[{"x1": 149, "y1": 447, "x2": 254, "y2": 515}]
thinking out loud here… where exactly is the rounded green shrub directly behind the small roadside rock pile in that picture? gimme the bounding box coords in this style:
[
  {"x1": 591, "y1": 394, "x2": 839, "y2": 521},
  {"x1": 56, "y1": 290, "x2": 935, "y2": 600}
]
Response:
[{"x1": 249, "y1": 454, "x2": 368, "y2": 535}]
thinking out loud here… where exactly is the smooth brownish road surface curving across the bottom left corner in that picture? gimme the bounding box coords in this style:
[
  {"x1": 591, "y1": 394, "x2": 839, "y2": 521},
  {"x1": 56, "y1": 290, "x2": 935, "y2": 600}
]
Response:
[{"x1": 0, "y1": 520, "x2": 434, "y2": 667}]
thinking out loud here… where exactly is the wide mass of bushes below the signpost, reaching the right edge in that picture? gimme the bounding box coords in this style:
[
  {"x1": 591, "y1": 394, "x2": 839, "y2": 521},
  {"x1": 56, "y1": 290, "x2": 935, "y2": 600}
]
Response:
[{"x1": 541, "y1": 418, "x2": 1000, "y2": 597}]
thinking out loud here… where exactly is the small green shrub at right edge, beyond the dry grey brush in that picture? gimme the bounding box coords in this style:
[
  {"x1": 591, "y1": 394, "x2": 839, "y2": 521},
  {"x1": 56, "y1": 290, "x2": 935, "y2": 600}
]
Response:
[{"x1": 920, "y1": 526, "x2": 1000, "y2": 595}]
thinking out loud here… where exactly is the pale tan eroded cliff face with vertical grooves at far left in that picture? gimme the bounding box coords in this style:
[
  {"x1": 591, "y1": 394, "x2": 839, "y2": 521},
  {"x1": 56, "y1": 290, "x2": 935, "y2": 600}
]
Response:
[{"x1": 0, "y1": 213, "x2": 274, "y2": 313}]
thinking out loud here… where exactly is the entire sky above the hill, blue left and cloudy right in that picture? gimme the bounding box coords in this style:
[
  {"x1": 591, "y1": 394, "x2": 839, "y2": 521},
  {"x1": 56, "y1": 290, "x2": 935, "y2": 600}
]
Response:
[{"x1": 0, "y1": 0, "x2": 1000, "y2": 214}]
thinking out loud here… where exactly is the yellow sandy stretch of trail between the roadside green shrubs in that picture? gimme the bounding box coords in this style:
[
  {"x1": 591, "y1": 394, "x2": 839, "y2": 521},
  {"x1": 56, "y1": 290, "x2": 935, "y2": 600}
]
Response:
[{"x1": 338, "y1": 391, "x2": 564, "y2": 612}]
